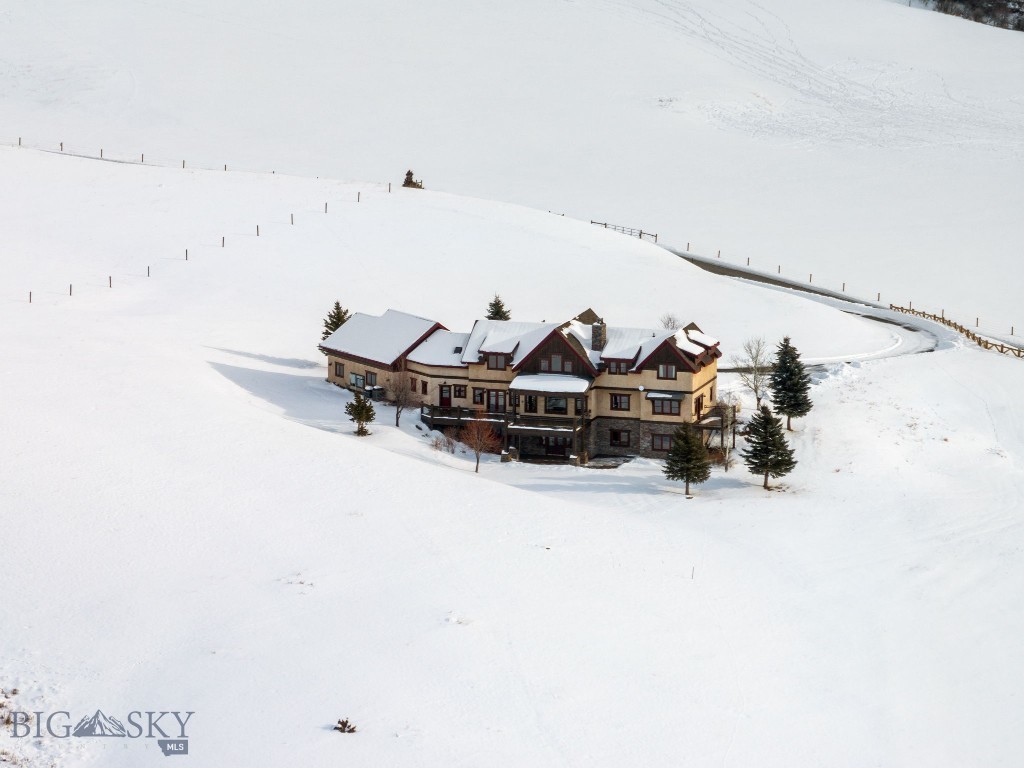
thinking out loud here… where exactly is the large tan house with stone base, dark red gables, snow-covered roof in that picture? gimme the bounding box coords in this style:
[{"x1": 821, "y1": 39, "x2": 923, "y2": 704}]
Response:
[{"x1": 321, "y1": 309, "x2": 722, "y2": 462}]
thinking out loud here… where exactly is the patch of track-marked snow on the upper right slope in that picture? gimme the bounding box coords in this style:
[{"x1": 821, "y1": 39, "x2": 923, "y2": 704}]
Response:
[{"x1": 623, "y1": 0, "x2": 1024, "y2": 153}]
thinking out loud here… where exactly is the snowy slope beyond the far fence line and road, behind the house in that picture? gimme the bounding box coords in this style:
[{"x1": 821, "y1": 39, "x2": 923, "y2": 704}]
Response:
[{"x1": 0, "y1": 0, "x2": 1024, "y2": 333}]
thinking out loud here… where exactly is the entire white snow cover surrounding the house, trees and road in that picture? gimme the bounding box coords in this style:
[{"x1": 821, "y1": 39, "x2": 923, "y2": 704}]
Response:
[{"x1": 0, "y1": 0, "x2": 1024, "y2": 767}]
